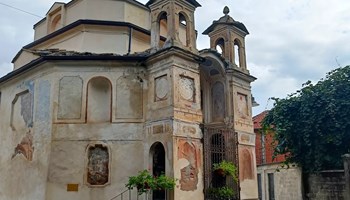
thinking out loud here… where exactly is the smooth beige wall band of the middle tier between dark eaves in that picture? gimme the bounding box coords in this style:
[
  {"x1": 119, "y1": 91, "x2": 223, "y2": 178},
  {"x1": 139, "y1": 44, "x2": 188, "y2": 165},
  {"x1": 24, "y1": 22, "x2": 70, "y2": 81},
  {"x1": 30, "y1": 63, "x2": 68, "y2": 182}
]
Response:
[{"x1": 14, "y1": 25, "x2": 150, "y2": 69}]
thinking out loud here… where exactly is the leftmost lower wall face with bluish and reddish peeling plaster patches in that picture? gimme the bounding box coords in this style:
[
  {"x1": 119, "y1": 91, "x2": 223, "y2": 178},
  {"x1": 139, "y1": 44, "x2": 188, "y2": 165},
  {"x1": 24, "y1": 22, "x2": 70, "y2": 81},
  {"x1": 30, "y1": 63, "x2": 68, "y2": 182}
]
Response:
[{"x1": 0, "y1": 67, "x2": 52, "y2": 200}]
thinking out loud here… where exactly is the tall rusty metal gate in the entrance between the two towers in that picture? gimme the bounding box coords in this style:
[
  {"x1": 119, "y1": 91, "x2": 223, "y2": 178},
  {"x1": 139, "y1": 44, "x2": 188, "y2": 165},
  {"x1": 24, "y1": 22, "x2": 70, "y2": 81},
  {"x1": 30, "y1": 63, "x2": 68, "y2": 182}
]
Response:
[{"x1": 203, "y1": 127, "x2": 239, "y2": 200}]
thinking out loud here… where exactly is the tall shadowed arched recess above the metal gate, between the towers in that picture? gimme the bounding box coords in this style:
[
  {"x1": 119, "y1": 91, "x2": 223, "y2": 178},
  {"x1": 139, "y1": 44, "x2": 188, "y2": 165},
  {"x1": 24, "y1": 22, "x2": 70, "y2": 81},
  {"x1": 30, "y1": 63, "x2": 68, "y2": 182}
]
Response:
[{"x1": 199, "y1": 53, "x2": 227, "y2": 124}]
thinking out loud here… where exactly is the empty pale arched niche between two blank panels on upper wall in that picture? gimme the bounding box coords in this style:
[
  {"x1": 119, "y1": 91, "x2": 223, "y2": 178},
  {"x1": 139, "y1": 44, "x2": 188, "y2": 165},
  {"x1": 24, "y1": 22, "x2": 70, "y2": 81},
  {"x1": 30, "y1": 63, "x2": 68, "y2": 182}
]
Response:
[{"x1": 86, "y1": 77, "x2": 112, "y2": 123}]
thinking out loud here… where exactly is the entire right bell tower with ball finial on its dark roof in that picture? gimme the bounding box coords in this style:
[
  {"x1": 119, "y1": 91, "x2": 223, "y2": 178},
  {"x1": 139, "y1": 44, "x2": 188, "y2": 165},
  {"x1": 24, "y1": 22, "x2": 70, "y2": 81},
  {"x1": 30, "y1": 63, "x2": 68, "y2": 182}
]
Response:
[{"x1": 201, "y1": 7, "x2": 258, "y2": 200}]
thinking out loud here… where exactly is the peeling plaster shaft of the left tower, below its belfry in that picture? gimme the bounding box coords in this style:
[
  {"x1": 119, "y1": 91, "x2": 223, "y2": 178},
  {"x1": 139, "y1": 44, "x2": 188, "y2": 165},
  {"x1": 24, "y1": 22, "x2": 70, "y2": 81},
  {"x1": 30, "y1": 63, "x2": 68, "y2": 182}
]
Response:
[{"x1": 145, "y1": 56, "x2": 204, "y2": 200}]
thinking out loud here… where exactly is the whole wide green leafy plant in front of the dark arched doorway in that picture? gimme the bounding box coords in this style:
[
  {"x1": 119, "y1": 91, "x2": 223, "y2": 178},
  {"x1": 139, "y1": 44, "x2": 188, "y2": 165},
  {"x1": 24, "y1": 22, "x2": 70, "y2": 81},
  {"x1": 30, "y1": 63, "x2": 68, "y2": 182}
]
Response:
[{"x1": 125, "y1": 170, "x2": 175, "y2": 195}]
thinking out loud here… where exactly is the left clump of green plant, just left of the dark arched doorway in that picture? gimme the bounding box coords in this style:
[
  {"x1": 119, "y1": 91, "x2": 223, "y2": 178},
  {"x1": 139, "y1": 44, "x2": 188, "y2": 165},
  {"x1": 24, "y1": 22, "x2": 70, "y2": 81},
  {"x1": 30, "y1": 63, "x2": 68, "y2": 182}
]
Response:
[{"x1": 125, "y1": 170, "x2": 155, "y2": 195}]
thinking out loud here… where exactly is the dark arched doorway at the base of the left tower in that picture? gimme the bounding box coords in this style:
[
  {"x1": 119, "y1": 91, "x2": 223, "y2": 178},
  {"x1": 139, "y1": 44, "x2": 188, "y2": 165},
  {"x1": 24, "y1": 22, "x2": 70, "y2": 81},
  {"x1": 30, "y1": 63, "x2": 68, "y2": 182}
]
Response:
[{"x1": 150, "y1": 142, "x2": 166, "y2": 200}]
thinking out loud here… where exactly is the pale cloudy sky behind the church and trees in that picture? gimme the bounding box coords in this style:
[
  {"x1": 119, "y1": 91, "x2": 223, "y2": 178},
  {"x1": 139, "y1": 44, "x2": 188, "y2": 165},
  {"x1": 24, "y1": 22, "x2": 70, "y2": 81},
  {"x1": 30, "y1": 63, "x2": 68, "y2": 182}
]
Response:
[{"x1": 0, "y1": 0, "x2": 350, "y2": 114}]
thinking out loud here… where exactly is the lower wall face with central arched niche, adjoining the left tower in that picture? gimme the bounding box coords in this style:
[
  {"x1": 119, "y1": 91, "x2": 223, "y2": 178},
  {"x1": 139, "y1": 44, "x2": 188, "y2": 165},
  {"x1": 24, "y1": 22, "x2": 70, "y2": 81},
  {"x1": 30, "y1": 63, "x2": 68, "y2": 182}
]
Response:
[{"x1": 46, "y1": 62, "x2": 149, "y2": 200}]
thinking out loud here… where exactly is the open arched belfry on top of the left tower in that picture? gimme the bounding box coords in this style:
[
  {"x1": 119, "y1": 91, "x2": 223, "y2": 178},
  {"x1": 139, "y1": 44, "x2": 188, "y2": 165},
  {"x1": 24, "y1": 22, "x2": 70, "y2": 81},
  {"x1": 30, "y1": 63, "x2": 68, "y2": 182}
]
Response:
[{"x1": 146, "y1": 0, "x2": 200, "y2": 52}]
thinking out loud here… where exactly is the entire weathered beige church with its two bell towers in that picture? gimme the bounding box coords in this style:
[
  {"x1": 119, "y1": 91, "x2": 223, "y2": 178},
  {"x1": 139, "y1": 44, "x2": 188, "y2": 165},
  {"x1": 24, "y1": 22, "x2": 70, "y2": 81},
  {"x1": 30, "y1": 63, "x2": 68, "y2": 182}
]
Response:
[{"x1": 0, "y1": 0, "x2": 258, "y2": 200}]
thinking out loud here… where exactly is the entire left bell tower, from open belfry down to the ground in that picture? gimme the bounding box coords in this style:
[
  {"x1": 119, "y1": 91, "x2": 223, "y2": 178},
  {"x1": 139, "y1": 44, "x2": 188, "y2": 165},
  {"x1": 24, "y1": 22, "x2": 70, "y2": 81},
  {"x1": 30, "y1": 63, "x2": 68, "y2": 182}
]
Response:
[{"x1": 144, "y1": 0, "x2": 204, "y2": 200}]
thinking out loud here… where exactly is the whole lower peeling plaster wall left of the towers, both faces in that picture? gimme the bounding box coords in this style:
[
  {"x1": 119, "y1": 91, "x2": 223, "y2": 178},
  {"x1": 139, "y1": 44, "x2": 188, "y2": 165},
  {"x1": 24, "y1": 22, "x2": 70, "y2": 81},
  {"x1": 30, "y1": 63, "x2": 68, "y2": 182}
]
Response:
[{"x1": 0, "y1": 62, "x2": 149, "y2": 200}]
